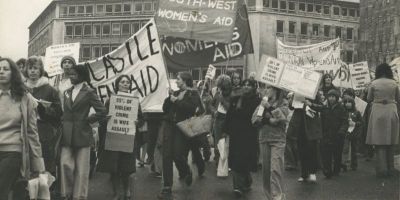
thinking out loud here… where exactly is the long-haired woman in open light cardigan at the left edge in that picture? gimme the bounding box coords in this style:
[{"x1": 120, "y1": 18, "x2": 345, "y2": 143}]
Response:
[{"x1": 0, "y1": 58, "x2": 45, "y2": 199}]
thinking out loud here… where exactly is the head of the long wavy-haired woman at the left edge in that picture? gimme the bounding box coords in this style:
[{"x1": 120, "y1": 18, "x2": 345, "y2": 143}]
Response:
[{"x1": 0, "y1": 58, "x2": 26, "y2": 101}]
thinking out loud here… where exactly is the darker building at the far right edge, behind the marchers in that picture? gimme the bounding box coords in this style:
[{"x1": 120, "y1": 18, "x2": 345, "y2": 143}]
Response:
[{"x1": 358, "y1": 0, "x2": 400, "y2": 69}]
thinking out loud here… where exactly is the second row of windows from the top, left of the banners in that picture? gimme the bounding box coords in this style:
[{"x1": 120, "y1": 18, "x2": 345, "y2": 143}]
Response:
[{"x1": 65, "y1": 21, "x2": 147, "y2": 37}]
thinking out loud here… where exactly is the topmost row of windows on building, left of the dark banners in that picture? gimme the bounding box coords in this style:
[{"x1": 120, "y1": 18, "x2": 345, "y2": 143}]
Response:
[{"x1": 60, "y1": 1, "x2": 157, "y2": 17}]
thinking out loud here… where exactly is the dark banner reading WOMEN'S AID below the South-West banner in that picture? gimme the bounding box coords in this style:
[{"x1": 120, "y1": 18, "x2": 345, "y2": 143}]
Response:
[{"x1": 161, "y1": 4, "x2": 253, "y2": 71}]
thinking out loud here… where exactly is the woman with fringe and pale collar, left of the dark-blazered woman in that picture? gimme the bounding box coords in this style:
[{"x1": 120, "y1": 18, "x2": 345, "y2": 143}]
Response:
[{"x1": 23, "y1": 56, "x2": 62, "y2": 175}]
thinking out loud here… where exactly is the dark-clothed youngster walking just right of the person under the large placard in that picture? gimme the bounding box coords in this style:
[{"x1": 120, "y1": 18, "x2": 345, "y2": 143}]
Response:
[{"x1": 321, "y1": 89, "x2": 348, "y2": 178}]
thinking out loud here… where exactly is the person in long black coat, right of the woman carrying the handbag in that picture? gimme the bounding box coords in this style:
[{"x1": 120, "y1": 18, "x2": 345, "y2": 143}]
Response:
[{"x1": 225, "y1": 80, "x2": 261, "y2": 196}]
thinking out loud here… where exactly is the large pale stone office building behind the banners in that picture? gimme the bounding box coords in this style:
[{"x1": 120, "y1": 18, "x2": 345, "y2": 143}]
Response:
[{"x1": 28, "y1": 0, "x2": 360, "y2": 80}]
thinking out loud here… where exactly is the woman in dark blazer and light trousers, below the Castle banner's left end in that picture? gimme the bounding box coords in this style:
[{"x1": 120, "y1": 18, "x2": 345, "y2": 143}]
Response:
[{"x1": 60, "y1": 65, "x2": 106, "y2": 199}]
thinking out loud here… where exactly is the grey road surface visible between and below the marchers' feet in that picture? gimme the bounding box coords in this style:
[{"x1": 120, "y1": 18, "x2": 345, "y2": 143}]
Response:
[{"x1": 89, "y1": 153, "x2": 400, "y2": 200}]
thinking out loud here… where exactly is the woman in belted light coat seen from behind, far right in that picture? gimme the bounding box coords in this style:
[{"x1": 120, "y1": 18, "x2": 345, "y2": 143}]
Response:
[{"x1": 366, "y1": 63, "x2": 400, "y2": 177}]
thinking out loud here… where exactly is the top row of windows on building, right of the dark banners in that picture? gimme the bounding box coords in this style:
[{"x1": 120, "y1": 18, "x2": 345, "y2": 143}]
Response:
[{"x1": 263, "y1": 0, "x2": 360, "y2": 17}]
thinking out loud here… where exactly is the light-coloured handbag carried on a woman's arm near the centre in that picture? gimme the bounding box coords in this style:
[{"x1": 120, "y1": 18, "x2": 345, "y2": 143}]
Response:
[{"x1": 176, "y1": 115, "x2": 212, "y2": 138}]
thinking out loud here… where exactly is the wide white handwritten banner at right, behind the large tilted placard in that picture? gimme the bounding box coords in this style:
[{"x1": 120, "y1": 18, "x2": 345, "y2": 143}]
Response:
[{"x1": 276, "y1": 39, "x2": 352, "y2": 88}]
